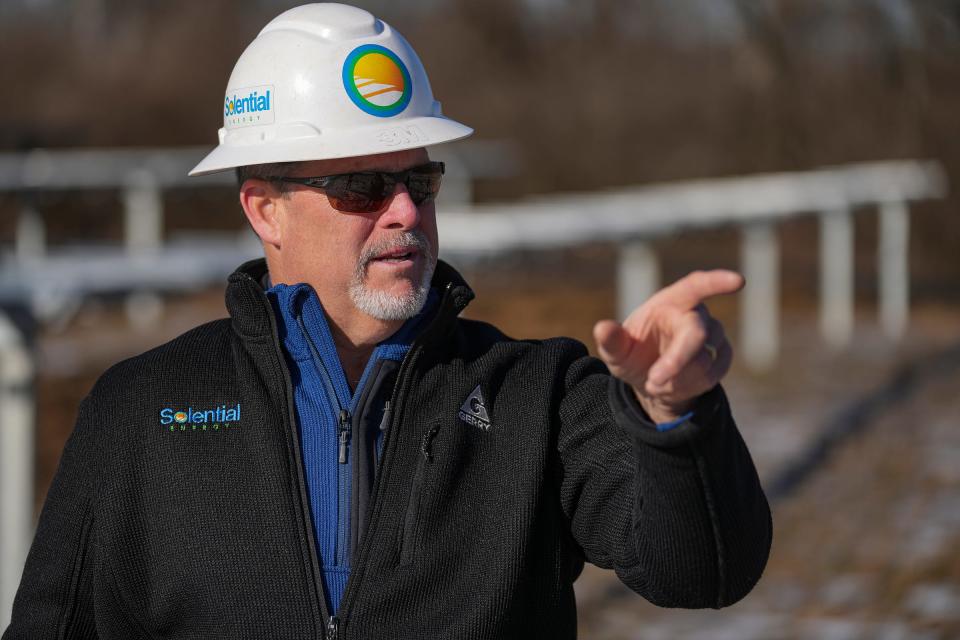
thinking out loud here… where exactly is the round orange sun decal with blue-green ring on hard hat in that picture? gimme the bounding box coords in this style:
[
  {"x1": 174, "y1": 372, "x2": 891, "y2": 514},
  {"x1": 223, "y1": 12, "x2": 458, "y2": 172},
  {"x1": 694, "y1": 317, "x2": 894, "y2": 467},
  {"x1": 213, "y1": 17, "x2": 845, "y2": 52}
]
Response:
[{"x1": 343, "y1": 44, "x2": 413, "y2": 118}]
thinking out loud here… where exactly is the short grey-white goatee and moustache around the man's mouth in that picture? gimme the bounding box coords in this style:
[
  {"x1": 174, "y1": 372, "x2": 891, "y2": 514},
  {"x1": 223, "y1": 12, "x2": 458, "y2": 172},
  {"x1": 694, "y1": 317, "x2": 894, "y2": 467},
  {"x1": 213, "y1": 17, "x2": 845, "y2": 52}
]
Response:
[{"x1": 348, "y1": 229, "x2": 436, "y2": 321}]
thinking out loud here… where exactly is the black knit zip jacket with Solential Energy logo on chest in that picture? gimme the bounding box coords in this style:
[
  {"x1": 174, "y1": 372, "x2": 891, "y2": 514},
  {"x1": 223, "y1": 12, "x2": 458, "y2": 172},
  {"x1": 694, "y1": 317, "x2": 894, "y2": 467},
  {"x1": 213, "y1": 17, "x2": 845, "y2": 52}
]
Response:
[{"x1": 3, "y1": 260, "x2": 771, "y2": 640}]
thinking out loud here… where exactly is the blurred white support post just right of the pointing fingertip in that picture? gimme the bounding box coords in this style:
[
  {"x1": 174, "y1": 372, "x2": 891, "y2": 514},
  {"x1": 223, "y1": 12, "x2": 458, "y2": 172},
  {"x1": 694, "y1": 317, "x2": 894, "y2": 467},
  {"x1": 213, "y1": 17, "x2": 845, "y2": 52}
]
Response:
[{"x1": 740, "y1": 222, "x2": 780, "y2": 372}]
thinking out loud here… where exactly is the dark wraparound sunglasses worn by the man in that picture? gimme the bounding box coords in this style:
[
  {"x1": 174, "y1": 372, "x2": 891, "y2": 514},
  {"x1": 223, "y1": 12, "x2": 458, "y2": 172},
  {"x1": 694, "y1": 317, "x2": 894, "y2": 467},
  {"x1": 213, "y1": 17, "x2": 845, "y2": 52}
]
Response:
[{"x1": 263, "y1": 162, "x2": 444, "y2": 213}]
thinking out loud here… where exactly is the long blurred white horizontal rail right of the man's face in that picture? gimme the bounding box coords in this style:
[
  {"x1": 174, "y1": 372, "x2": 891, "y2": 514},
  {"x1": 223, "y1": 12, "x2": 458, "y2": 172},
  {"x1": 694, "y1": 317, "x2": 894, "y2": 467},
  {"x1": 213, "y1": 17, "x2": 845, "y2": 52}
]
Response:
[{"x1": 437, "y1": 163, "x2": 945, "y2": 254}]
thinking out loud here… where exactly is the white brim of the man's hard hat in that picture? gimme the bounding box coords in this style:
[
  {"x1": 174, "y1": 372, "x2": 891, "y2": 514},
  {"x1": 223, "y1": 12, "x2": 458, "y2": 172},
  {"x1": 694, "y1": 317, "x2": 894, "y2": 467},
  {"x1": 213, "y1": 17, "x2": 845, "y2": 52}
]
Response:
[{"x1": 188, "y1": 116, "x2": 473, "y2": 176}]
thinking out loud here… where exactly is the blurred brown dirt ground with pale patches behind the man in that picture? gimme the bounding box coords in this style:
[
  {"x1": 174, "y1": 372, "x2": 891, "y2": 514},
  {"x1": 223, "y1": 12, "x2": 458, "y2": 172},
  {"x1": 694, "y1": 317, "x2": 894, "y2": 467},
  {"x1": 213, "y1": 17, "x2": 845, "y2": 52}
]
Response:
[{"x1": 30, "y1": 250, "x2": 960, "y2": 640}]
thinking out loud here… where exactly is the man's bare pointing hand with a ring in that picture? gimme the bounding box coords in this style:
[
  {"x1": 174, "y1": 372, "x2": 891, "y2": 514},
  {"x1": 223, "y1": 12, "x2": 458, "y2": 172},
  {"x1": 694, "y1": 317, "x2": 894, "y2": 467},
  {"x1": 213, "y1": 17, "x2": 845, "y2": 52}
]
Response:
[{"x1": 593, "y1": 269, "x2": 744, "y2": 423}]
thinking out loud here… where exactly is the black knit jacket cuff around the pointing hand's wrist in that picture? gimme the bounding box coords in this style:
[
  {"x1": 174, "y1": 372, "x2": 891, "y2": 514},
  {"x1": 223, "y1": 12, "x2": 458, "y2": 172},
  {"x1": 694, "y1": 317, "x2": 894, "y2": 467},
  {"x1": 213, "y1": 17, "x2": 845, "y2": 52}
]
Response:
[{"x1": 608, "y1": 376, "x2": 727, "y2": 449}]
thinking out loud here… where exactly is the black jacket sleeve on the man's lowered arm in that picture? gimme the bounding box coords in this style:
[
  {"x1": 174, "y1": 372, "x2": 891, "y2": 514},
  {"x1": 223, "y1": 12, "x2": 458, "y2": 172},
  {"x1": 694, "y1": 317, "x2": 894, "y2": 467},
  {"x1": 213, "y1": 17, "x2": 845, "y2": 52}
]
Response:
[{"x1": 2, "y1": 397, "x2": 102, "y2": 640}]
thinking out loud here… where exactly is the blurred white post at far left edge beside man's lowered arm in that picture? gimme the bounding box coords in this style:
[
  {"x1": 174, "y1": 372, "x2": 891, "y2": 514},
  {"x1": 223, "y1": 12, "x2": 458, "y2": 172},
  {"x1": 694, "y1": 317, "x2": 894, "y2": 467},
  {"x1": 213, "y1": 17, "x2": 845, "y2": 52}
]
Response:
[{"x1": 0, "y1": 313, "x2": 35, "y2": 629}]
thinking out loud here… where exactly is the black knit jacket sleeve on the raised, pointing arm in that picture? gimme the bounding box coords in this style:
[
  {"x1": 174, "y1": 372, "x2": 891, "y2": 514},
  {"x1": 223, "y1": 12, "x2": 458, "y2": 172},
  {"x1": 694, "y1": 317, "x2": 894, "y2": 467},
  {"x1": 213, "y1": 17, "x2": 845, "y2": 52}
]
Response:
[{"x1": 558, "y1": 348, "x2": 772, "y2": 608}]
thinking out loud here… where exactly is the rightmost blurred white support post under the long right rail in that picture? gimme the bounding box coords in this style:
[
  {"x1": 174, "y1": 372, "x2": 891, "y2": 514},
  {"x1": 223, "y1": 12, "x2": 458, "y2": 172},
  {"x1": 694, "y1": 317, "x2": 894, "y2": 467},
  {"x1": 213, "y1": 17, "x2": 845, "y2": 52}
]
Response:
[{"x1": 877, "y1": 202, "x2": 910, "y2": 340}]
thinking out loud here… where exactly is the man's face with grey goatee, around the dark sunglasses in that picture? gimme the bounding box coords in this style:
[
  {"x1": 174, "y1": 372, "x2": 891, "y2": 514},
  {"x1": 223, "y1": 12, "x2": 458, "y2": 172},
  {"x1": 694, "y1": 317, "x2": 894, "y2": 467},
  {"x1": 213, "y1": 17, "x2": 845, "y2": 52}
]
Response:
[{"x1": 273, "y1": 149, "x2": 438, "y2": 320}]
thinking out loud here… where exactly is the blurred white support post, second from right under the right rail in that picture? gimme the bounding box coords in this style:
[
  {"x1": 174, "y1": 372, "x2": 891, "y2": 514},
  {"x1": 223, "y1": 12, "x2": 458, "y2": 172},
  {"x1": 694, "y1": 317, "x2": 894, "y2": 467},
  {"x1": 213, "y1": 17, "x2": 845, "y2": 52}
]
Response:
[{"x1": 820, "y1": 209, "x2": 855, "y2": 349}]
